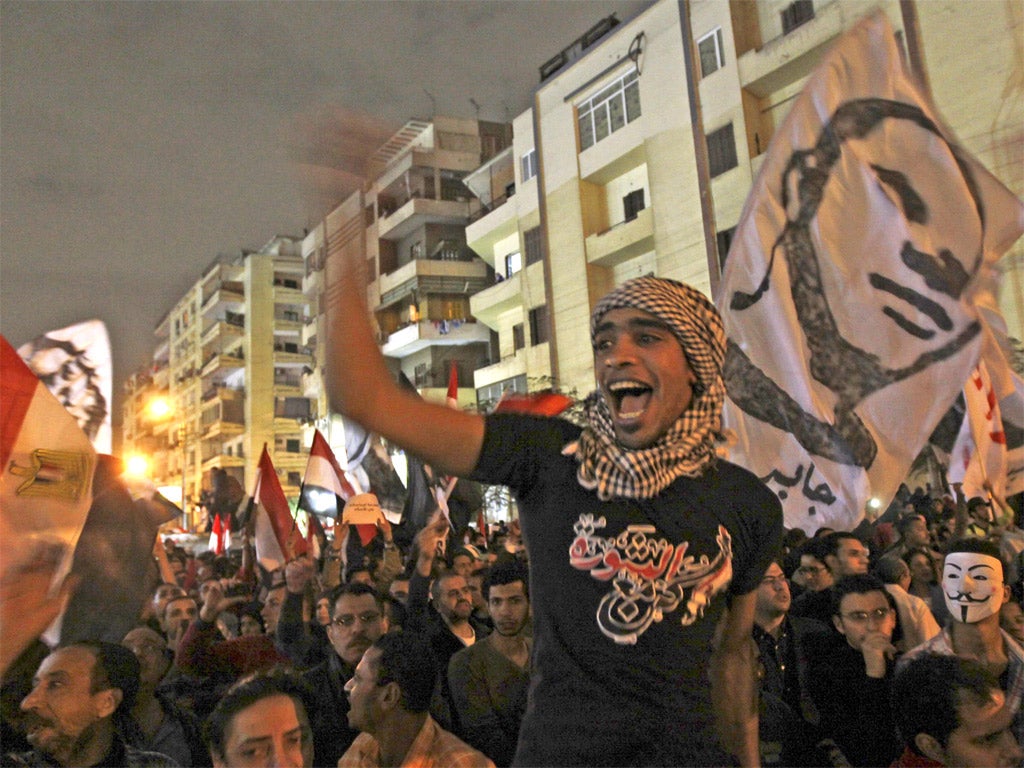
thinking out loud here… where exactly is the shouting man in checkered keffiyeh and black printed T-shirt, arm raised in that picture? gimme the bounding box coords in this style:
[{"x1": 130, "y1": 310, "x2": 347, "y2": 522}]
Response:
[{"x1": 326, "y1": 268, "x2": 782, "y2": 766}]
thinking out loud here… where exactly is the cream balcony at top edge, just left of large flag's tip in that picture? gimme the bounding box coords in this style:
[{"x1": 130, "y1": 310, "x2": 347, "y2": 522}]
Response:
[{"x1": 736, "y1": 2, "x2": 847, "y2": 98}]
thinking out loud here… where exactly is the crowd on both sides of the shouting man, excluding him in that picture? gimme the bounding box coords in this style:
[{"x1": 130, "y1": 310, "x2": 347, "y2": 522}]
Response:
[{"x1": 3, "y1": 481, "x2": 1024, "y2": 766}]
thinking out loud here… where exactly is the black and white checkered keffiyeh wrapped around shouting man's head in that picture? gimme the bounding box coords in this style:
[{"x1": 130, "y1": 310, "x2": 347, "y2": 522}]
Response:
[{"x1": 566, "y1": 276, "x2": 725, "y2": 501}]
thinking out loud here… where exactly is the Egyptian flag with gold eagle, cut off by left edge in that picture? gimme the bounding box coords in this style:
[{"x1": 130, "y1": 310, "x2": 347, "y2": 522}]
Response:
[{"x1": 0, "y1": 336, "x2": 95, "y2": 578}]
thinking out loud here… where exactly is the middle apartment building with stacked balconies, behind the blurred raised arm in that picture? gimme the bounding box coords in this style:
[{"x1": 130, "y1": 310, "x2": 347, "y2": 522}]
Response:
[{"x1": 302, "y1": 116, "x2": 512, "y2": 443}]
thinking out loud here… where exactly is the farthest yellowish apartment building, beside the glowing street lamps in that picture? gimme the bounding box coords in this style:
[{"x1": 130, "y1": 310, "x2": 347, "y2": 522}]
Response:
[{"x1": 125, "y1": 236, "x2": 316, "y2": 523}]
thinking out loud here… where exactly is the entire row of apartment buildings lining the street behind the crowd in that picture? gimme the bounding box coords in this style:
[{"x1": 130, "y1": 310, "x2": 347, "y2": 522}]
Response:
[{"x1": 125, "y1": 0, "x2": 1024, "y2": 524}]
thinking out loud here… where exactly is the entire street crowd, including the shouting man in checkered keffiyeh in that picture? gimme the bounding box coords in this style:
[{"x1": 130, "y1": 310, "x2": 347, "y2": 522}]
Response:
[{"x1": 0, "y1": 275, "x2": 1024, "y2": 768}]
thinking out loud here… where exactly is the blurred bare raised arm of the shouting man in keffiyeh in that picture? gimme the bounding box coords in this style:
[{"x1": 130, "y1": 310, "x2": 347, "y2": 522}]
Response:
[{"x1": 325, "y1": 249, "x2": 483, "y2": 476}]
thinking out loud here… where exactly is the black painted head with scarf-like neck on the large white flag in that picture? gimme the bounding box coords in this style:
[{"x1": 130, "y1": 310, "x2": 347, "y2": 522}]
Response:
[{"x1": 723, "y1": 98, "x2": 984, "y2": 469}]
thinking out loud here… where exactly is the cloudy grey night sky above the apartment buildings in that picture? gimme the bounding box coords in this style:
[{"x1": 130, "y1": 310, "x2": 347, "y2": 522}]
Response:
[{"x1": 0, "y1": 0, "x2": 649, "y2": 421}]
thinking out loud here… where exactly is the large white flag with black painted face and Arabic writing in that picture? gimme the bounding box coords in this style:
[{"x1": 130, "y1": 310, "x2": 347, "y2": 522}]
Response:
[{"x1": 716, "y1": 14, "x2": 1024, "y2": 531}]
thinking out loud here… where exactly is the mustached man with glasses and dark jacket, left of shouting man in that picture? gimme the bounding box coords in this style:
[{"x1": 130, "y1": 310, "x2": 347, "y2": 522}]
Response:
[{"x1": 303, "y1": 582, "x2": 387, "y2": 765}]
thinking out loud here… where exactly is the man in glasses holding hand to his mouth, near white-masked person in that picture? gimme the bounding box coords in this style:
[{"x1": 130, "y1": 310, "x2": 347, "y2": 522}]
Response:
[{"x1": 809, "y1": 573, "x2": 901, "y2": 766}]
